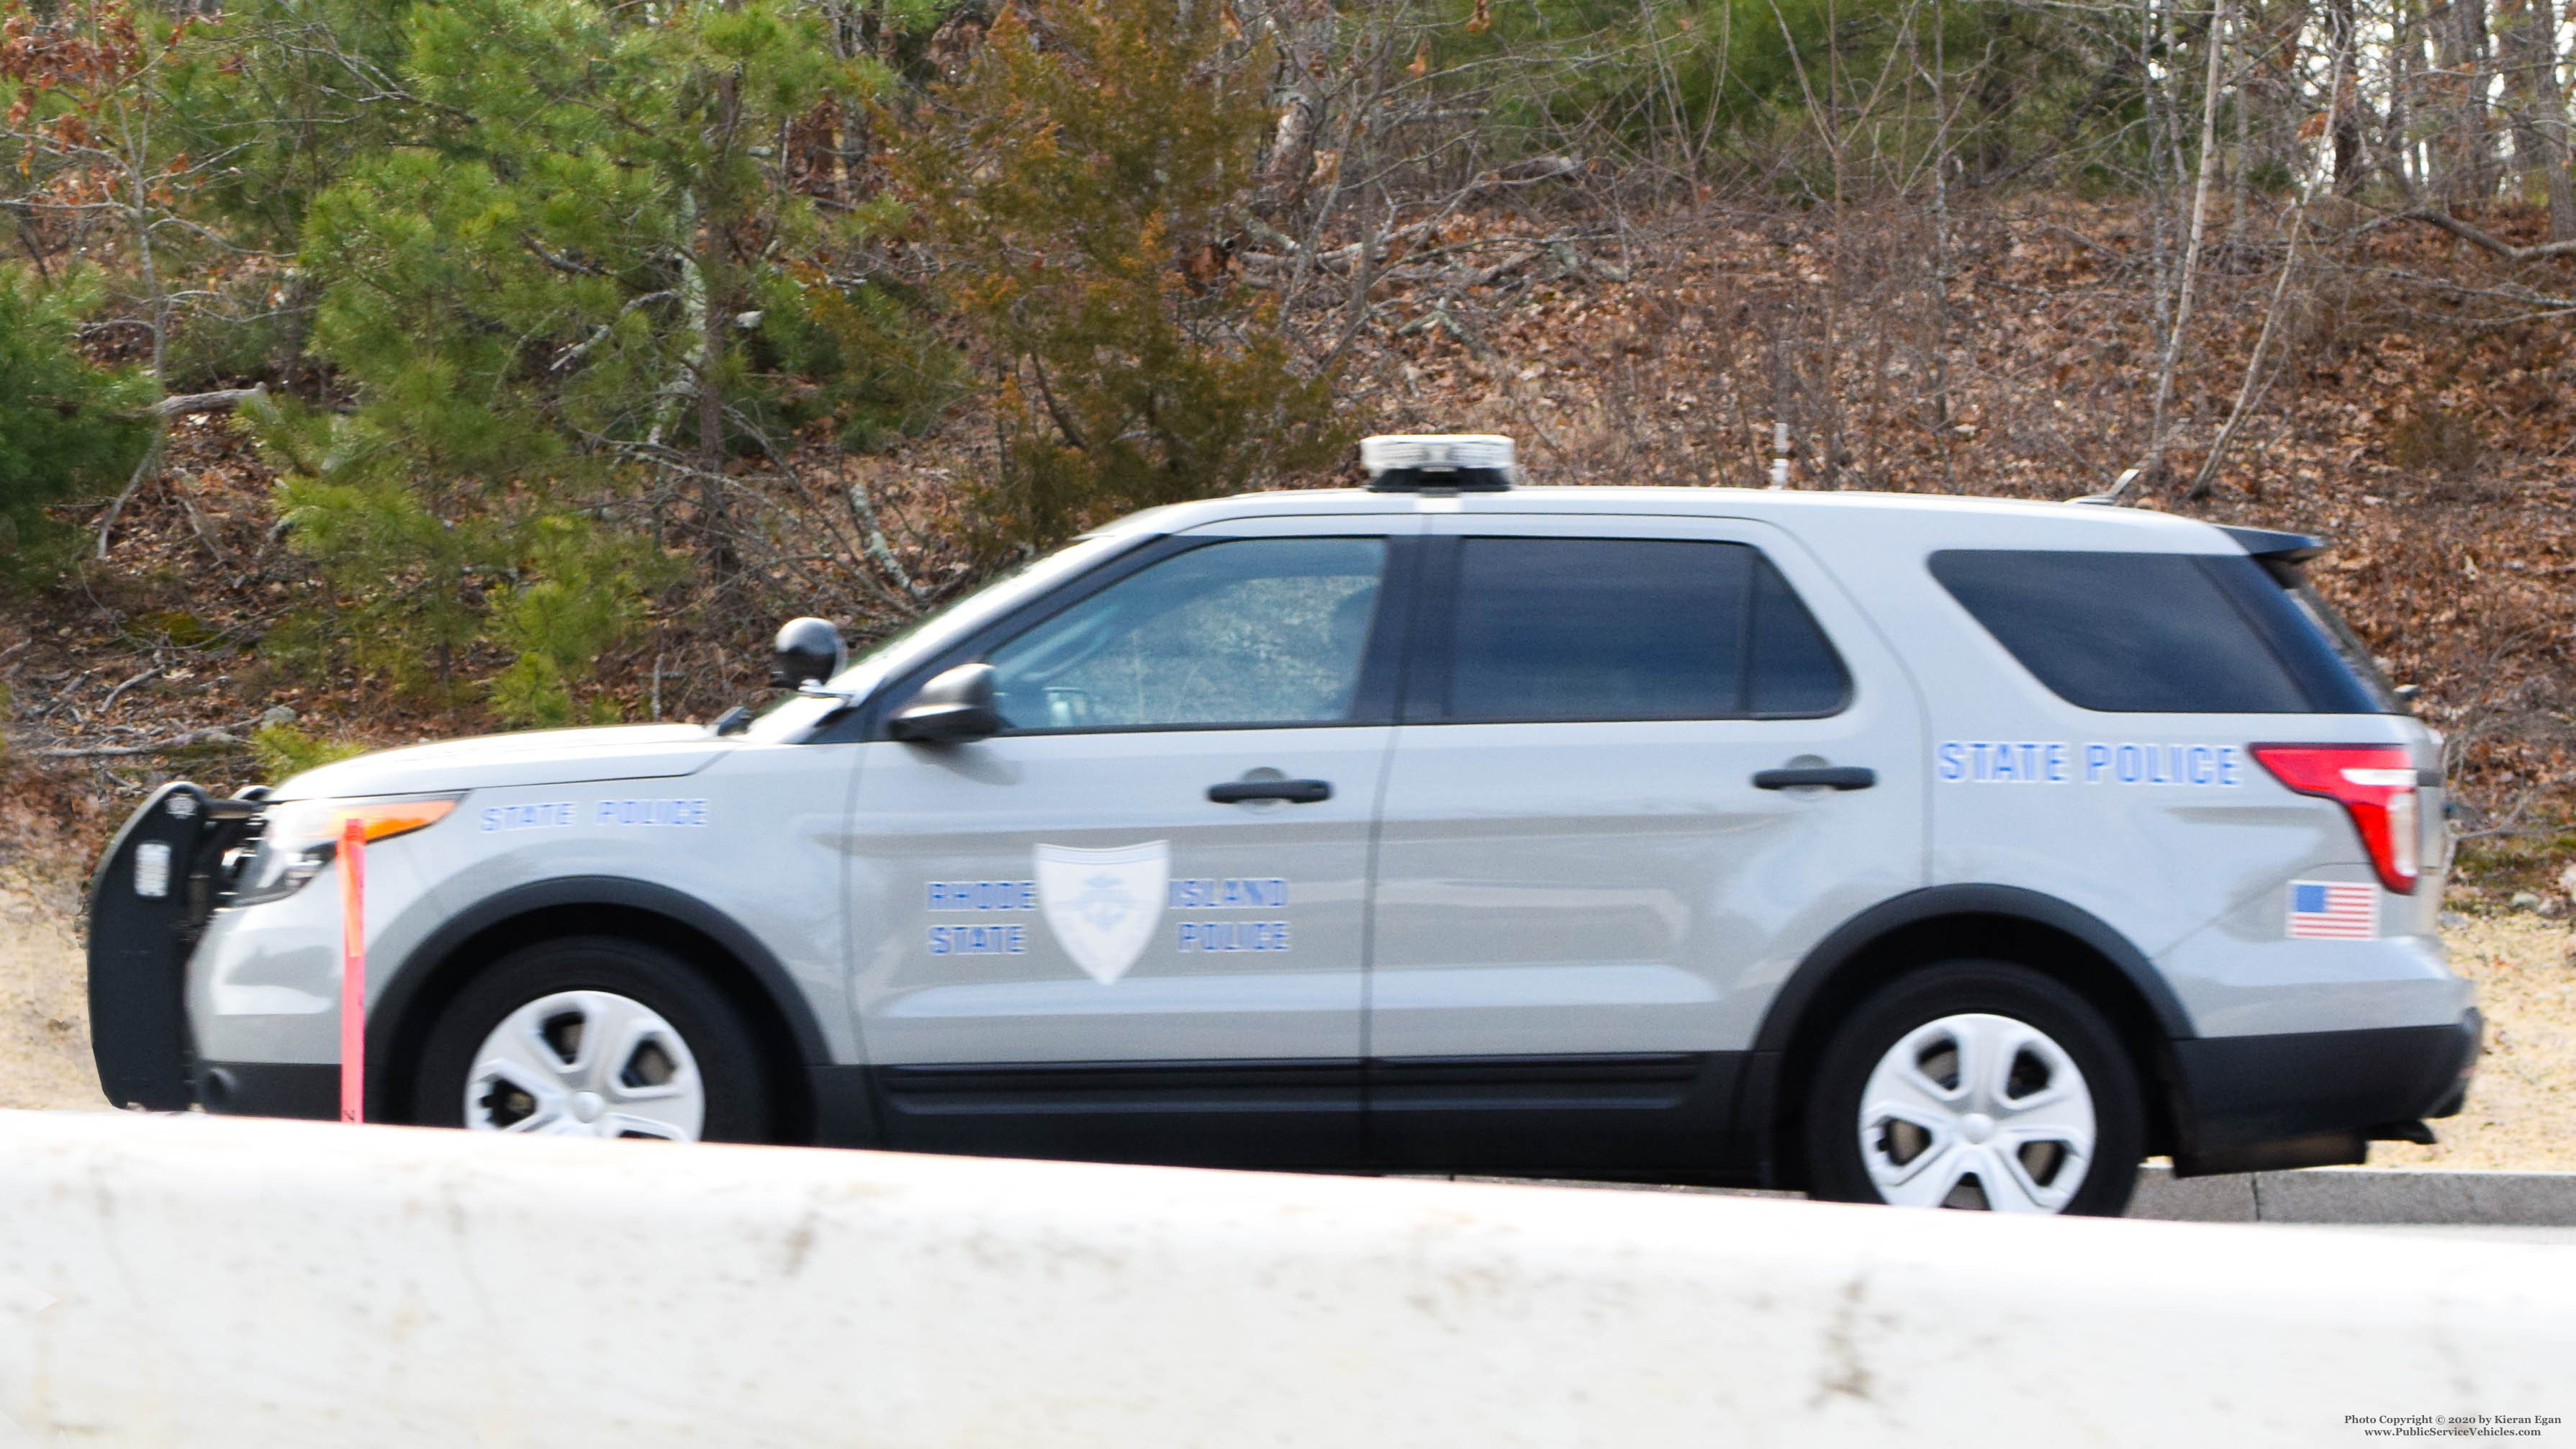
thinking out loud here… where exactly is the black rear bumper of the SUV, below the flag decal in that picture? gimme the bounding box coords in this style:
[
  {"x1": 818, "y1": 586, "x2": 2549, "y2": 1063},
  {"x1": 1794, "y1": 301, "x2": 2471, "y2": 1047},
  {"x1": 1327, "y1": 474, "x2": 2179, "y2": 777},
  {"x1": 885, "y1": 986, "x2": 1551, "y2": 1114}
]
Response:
[{"x1": 2174, "y1": 1011, "x2": 2486, "y2": 1175}]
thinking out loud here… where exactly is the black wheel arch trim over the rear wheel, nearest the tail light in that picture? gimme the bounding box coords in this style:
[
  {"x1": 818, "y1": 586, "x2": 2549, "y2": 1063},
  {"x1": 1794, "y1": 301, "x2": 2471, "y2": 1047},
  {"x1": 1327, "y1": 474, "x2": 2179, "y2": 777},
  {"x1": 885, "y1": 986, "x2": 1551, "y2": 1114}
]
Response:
[{"x1": 1739, "y1": 885, "x2": 2195, "y2": 1186}]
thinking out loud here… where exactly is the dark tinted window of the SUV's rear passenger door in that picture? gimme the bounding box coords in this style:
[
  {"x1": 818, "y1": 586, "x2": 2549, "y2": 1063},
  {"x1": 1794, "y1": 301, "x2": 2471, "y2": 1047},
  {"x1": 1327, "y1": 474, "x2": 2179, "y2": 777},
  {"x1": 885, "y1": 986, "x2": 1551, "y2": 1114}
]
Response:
[{"x1": 1435, "y1": 539, "x2": 1850, "y2": 722}]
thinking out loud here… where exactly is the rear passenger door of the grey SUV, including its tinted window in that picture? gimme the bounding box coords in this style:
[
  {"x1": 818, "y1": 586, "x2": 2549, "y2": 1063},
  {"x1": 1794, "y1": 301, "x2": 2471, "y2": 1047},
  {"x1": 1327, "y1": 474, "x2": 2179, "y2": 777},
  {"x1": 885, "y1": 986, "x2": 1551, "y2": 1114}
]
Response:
[{"x1": 1368, "y1": 515, "x2": 1925, "y2": 1168}]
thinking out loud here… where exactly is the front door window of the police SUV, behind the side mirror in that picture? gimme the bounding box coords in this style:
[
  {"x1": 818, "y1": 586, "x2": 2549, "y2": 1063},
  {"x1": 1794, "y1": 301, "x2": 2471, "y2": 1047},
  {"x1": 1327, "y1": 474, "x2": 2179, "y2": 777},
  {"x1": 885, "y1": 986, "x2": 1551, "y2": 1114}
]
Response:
[{"x1": 989, "y1": 539, "x2": 1386, "y2": 730}]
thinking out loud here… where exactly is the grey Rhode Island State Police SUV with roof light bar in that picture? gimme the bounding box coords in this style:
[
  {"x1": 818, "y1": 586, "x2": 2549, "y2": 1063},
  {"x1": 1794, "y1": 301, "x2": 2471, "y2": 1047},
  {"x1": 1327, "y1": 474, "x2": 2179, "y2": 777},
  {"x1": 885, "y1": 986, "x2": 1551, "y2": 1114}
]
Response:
[{"x1": 90, "y1": 438, "x2": 2481, "y2": 1214}]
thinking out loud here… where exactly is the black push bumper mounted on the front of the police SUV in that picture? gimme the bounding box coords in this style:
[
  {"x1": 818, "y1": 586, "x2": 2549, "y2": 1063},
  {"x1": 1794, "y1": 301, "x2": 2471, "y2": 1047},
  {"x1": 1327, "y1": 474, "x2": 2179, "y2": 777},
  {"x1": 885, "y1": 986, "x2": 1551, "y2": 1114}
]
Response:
[{"x1": 90, "y1": 781, "x2": 266, "y2": 1111}]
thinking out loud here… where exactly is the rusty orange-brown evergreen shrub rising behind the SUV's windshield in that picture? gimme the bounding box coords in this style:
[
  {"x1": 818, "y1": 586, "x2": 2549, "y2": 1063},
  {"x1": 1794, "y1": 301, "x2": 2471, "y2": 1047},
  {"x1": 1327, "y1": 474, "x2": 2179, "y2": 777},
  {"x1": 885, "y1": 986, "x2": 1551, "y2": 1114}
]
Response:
[{"x1": 881, "y1": 0, "x2": 1350, "y2": 552}]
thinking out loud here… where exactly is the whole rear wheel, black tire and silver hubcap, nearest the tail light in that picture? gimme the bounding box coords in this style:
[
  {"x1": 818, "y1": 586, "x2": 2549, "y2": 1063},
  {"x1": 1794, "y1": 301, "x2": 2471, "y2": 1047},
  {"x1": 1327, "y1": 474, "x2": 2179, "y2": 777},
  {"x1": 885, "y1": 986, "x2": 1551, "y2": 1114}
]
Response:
[{"x1": 1806, "y1": 962, "x2": 2146, "y2": 1217}]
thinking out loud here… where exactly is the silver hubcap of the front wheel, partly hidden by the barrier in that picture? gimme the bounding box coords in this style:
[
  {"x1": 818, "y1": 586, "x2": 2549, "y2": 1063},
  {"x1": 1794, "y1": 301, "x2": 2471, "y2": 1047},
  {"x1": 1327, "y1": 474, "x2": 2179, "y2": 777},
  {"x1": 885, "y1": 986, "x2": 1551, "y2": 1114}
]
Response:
[{"x1": 466, "y1": 990, "x2": 706, "y2": 1142}]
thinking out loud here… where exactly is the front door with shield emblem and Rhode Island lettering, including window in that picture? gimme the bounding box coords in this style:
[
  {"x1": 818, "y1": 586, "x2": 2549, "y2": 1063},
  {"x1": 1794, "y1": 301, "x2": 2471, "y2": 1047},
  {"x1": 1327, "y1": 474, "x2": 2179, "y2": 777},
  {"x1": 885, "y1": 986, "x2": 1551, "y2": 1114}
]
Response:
[{"x1": 850, "y1": 518, "x2": 1396, "y2": 1165}]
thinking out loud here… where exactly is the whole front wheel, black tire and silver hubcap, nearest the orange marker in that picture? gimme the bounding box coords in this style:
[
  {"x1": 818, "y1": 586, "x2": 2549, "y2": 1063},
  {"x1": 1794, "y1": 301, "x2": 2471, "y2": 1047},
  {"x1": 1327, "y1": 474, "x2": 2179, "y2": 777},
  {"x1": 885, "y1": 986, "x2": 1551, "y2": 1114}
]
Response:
[{"x1": 412, "y1": 936, "x2": 770, "y2": 1142}]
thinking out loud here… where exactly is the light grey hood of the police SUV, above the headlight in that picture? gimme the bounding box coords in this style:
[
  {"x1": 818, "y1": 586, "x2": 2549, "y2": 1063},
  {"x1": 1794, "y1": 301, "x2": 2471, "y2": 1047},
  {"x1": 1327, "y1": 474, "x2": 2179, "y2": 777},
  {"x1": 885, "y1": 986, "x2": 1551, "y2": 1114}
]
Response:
[{"x1": 276, "y1": 725, "x2": 734, "y2": 799}]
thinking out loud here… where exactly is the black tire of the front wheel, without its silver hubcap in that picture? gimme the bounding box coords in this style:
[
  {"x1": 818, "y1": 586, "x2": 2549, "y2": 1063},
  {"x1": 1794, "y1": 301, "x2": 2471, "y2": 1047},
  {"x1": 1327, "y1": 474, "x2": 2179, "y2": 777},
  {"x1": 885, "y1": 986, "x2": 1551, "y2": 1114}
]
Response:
[{"x1": 412, "y1": 936, "x2": 773, "y2": 1142}]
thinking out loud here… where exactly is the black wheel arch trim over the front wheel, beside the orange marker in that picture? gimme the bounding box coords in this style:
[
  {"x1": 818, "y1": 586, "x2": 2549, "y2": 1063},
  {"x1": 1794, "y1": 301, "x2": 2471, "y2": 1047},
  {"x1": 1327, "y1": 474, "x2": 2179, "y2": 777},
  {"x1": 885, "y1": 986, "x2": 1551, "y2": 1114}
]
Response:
[{"x1": 366, "y1": 877, "x2": 832, "y2": 1142}]
